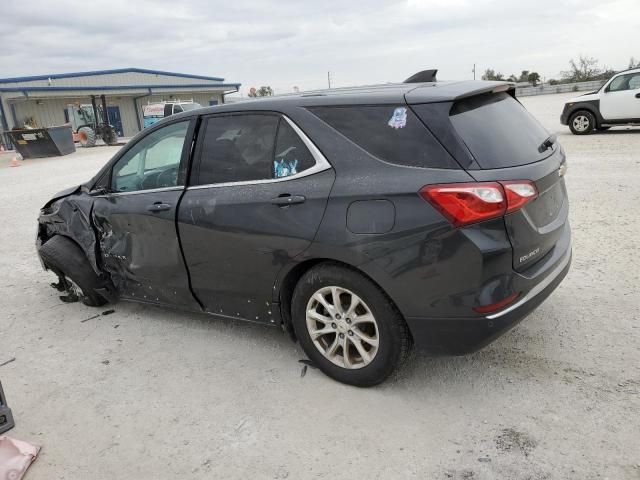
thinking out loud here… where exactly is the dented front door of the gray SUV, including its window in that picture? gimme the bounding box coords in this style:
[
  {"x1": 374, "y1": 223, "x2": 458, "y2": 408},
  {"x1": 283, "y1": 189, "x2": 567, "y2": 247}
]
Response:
[{"x1": 93, "y1": 121, "x2": 199, "y2": 309}]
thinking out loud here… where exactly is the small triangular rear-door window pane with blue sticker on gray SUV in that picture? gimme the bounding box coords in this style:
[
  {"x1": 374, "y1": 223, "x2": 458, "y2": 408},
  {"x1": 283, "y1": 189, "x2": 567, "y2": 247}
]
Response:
[{"x1": 273, "y1": 118, "x2": 315, "y2": 178}]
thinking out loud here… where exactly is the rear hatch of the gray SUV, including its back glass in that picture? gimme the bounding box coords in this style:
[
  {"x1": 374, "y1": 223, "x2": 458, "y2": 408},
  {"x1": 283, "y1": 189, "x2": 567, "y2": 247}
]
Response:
[{"x1": 412, "y1": 91, "x2": 568, "y2": 272}]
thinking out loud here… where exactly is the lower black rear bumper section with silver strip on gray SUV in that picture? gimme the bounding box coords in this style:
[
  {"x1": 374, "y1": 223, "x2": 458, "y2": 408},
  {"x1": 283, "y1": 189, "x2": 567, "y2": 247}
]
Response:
[{"x1": 406, "y1": 248, "x2": 572, "y2": 355}]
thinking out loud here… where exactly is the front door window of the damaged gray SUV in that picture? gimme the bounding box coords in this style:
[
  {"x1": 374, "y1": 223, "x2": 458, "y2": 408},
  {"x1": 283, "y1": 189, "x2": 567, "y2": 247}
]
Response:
[{"x1": 111, "y1": 122, "x2": 189, "y2": 192}]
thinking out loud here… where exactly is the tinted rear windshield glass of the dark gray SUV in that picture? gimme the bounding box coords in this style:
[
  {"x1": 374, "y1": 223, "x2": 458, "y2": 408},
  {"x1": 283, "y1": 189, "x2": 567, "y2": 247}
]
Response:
[{"x1": 449, "y1": 93, "x2": 555, "y2": 169}]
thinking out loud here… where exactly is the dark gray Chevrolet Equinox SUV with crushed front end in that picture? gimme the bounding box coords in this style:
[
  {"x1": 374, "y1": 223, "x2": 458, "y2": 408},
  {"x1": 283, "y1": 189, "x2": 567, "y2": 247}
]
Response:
[{"x1": 37, "y1": 81, "x2": 571, "y2": 386}]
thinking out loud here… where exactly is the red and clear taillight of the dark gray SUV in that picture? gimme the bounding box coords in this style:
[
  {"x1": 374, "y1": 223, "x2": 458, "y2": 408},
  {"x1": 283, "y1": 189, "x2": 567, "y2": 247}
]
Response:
[{"x1": 419, "y1": 180, "x2": 538, "y2": 227}]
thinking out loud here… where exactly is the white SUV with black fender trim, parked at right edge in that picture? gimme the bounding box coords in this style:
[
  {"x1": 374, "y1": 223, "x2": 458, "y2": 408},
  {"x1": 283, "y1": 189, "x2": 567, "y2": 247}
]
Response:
[{"x1": 560, "y1": 68, "x2": 640, "y2": 135}]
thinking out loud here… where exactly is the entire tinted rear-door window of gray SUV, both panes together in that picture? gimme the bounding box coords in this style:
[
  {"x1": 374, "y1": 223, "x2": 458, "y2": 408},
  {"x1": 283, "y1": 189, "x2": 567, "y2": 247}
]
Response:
[{"x1": 194, "y1": 114, "x2": 315, "y2": 185}]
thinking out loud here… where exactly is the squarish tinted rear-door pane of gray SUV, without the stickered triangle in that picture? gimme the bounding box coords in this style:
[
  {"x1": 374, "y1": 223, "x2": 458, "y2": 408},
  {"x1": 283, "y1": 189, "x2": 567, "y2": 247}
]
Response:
[{"x1": 194, "y1": 114, "x2": 279, "y2": 185}]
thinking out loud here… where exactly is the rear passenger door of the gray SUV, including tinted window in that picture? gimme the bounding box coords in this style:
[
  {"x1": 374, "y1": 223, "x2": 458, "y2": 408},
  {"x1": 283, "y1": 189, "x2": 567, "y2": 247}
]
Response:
[{"x1": 178, "y1": 114, "x2": 335, "y2": 322}]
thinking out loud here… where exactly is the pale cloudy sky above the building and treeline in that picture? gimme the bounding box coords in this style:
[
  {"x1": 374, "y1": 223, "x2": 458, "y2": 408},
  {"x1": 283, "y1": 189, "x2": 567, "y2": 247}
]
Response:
[{"x1": 0, "y1": 0, "x2": 640, "y2": 95}]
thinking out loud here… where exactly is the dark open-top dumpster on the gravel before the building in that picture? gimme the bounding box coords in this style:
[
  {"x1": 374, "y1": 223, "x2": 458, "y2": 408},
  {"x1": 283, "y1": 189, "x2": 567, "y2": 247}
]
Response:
[{"x1": 6, "y1": 125, "x2": 76, "y2": 158}]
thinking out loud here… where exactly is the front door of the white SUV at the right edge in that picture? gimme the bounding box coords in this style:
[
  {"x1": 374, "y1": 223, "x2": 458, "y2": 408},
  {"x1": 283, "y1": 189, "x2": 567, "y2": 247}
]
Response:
[{"x1": 600, "y1": 72, "x2": 640, "y2": 120}]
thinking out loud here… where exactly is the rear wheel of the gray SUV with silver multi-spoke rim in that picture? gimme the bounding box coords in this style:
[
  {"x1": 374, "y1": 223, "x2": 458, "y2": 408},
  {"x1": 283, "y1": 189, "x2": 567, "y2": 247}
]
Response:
[{"x1": 291, "y1": 263, "x2": 411, "y2": 387}]
